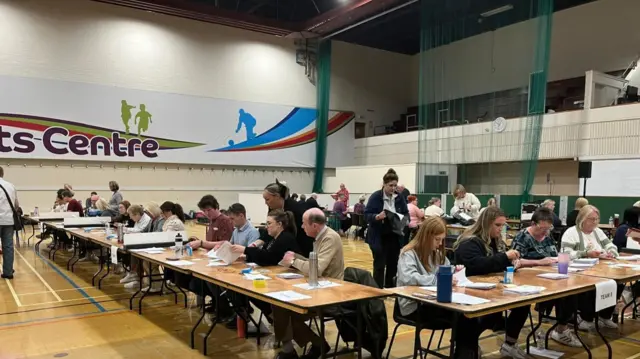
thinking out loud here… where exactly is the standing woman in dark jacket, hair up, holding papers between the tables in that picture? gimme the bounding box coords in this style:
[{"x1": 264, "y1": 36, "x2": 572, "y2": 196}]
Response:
[{"x1": 364, "y1": 168, "x2": 409, "y2": 288}]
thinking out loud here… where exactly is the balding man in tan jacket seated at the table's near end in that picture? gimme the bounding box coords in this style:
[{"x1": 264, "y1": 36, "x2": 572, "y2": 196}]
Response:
[{"x1": 273, "y1": 208, "x2": 344, "y2": 359}]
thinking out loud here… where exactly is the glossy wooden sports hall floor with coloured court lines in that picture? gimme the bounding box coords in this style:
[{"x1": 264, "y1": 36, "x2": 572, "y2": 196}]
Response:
[{"x1": 0, "y1": 226, "x2": 640, "y2": 359}]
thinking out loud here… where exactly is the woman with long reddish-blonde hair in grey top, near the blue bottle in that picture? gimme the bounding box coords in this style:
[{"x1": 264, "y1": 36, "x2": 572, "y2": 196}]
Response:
[{"x1": 396, "y1": 216, "x2": 481, "y2": 358}]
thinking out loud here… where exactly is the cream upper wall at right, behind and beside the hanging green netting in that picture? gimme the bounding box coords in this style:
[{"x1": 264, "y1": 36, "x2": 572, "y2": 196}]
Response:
[{"x1": 411, "y1": 0, "x2": 640, "y2": 105}]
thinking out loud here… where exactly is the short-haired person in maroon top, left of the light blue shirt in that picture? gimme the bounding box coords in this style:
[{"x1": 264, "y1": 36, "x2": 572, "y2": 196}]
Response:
[{"x1": 189, "y1": 194, "x2": 233, "y2": 250}]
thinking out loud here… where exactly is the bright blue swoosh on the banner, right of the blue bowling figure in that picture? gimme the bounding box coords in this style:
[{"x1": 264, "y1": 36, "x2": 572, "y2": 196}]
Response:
[{"x1": 208, "y1": 108, "x2": 317, "y2": 152}]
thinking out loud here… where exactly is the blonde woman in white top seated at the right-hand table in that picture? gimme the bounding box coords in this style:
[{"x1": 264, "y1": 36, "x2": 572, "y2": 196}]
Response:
[{"x1": 561, "y1": 205, "x2": 624, "y2": 330}]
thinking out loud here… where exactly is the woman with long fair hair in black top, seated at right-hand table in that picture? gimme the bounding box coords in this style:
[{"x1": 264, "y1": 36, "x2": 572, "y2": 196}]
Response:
[{"x1": 453, "y1": 207, "x2": 529, "y2": 358}]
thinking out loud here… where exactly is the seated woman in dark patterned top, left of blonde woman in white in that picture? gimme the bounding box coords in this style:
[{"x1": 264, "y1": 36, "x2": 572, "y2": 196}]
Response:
[{"x1": 511, "y1": 207, "x2": 582, "y2": 348}]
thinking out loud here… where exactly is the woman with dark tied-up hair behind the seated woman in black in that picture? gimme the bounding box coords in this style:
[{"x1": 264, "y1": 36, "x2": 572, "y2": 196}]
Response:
[{"x1": 258, "y1": 179, "x2": 313, "y2": 258}]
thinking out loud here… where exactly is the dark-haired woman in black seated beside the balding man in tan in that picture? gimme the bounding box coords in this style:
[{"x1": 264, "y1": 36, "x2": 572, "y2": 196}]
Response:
[{"x1": 232, "y1": 209, "x2": 299, "y2": 267}]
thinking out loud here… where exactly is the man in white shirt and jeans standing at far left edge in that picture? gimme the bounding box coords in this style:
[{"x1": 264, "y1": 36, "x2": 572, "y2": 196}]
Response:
[{"x1": 0, "y1": 167, "x2": 18, "y2": 279}]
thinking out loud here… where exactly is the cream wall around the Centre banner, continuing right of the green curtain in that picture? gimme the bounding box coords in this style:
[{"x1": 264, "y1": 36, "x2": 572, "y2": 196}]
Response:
[{"x1": 0, "y1": 0, "x2": 409, "y2": 209}]
